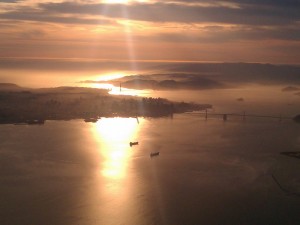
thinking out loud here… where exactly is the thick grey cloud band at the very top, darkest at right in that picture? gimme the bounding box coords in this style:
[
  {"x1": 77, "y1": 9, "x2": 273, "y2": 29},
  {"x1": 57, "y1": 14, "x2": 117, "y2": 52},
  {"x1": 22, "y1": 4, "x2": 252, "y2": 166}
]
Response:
[{"x1": 39, "y1": 1, "x2": 300, "y2": 25}]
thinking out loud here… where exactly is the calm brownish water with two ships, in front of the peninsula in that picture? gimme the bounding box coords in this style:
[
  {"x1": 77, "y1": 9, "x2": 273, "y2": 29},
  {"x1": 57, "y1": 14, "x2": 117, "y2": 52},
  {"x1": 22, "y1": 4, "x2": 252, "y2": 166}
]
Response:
[{"x1": 0, "y1": 89, "x2": 300, "y2": 225}]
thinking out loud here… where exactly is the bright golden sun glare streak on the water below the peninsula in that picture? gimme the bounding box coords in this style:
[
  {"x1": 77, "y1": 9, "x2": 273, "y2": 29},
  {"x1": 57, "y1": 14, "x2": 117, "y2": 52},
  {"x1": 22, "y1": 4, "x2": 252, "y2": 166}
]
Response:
[{"x1": 89, "y1": 117, "x2": 148, "y2": 224}]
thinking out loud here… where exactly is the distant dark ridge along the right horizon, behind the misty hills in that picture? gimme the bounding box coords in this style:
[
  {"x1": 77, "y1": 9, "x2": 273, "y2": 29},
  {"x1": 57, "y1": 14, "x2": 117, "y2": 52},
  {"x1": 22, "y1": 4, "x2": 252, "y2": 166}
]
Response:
[{"x1": 165, "y1": 63, "x2": 300, "y2": 85}]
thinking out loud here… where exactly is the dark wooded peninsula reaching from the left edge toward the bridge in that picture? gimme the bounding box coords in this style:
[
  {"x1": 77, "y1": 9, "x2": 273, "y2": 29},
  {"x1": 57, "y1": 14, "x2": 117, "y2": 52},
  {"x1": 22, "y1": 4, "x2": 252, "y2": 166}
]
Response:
[{"x1": 0, "y1": 84, "x2": 211, "y2": 124}]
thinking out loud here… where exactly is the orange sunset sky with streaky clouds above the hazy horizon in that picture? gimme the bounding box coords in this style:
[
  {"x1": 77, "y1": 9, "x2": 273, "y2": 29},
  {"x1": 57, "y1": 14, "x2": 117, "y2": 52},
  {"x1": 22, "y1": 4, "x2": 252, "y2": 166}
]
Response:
[{"x1": 0, "y1": 0, "x2": 300, "y2": 86}]
